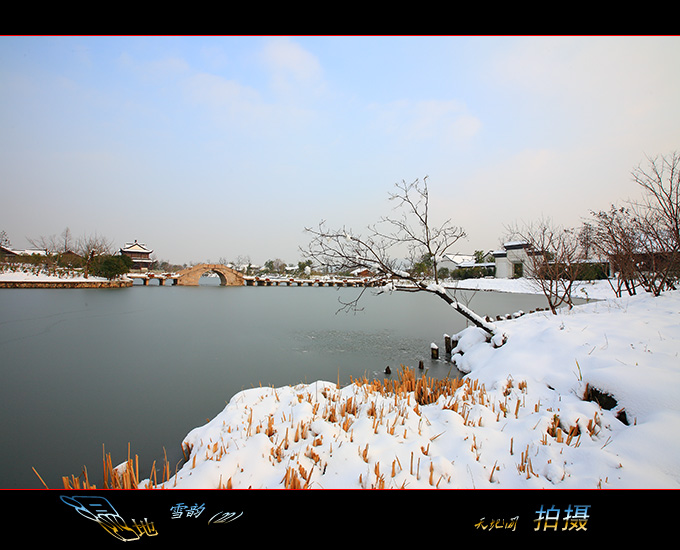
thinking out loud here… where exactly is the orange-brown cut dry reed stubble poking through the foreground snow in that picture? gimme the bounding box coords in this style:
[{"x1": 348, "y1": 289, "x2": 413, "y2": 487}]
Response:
[{"x1": 57, "y1": 365, "x2": 584, "y2": 489}]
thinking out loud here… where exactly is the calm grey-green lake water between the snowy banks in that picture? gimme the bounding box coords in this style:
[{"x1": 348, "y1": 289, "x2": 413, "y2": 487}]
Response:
[{"x1": 0, "y1": 279, "x2": 546, "y2": 489}]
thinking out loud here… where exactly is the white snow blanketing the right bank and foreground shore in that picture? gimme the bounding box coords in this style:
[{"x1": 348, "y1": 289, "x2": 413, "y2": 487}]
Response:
[{"x1": 146, "y1": 279, "x2": 680, "y2": 489}]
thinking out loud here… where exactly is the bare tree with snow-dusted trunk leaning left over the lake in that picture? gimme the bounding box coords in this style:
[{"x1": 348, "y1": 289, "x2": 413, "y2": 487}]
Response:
[{"x1": 301, "y1": 178, "x2": 497, "y2": 337}]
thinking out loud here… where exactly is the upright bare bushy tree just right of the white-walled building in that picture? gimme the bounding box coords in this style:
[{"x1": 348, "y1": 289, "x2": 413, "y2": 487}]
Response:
[{"x1": 510, "y1": 219, "x2": 582, "y2": 314}]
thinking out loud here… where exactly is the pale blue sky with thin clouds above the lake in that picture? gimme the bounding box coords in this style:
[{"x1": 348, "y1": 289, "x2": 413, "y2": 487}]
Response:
[{"x1": 0, "y1": 36, "x2": 680, "y2": 264}]
